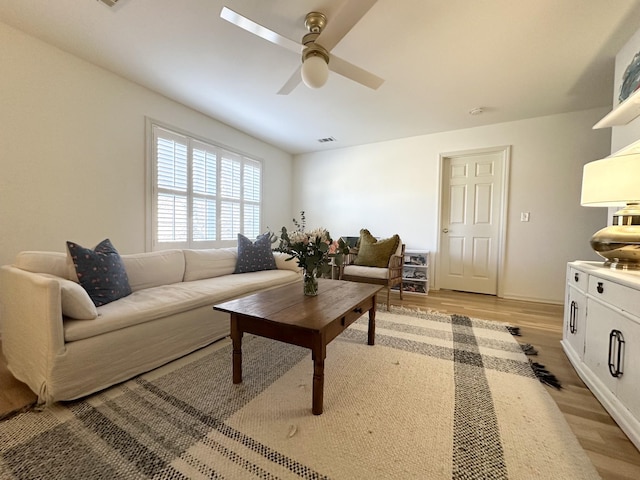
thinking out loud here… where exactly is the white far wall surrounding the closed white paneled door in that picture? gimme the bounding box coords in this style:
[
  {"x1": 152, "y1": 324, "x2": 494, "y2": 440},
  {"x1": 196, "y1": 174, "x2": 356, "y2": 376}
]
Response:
[{"x1": 293, "y1": 109, "x2": 610, "y2": 303}]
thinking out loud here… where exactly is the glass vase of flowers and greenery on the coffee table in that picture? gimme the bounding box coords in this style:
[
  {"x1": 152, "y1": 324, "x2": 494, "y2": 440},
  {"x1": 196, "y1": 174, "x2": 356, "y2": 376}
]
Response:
[{"x1": 271, "y1": 211, "x2": 349, "y2": 296}]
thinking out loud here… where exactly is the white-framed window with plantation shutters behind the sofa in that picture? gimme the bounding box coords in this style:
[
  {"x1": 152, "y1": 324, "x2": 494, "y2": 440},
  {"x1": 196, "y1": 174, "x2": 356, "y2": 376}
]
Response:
[{"x1": 151, "y1": 124, "x2": 262, "y2": 249}]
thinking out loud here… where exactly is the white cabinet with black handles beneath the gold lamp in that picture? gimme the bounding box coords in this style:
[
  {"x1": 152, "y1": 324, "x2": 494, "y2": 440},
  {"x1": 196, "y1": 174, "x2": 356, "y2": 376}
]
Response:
[{"x1": 562, "y1": 262, "x2": 640, "y2": 448}]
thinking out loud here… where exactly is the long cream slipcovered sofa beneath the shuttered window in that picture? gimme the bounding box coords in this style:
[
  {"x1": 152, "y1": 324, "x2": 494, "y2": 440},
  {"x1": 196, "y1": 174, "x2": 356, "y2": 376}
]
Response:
[{"x1": 0, "y1": 248, "x2": 302, "y2": 404}]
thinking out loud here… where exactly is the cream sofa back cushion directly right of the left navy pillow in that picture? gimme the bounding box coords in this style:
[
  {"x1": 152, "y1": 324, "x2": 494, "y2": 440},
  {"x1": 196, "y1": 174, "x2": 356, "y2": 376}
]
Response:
[{"x1": 121, "y1": 249, "x2": 185, "y2": 292}]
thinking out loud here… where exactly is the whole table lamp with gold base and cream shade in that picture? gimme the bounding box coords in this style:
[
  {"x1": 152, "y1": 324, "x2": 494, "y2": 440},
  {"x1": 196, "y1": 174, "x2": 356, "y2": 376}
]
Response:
[{"x1": 580, "y1": 153, "x2": 640, "y2": 269}]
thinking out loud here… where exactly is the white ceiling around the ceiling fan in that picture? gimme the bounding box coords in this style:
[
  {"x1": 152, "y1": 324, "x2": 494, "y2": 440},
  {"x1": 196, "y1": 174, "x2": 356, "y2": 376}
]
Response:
[{"x1": 0, "y1": 0, "x2": 640, "y2": 154}]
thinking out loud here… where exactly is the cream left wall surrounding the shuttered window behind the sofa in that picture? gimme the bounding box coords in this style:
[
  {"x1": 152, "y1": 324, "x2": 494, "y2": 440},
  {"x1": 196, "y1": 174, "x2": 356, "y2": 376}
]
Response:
[{"x1": 0, "y1": 23, "x2": 292, "y2": 265}]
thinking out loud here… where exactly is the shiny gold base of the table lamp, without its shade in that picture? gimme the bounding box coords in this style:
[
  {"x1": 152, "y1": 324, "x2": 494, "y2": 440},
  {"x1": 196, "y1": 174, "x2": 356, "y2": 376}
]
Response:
[{"x1": 591, "y1": 203, "x2": 640, "y2": 270}]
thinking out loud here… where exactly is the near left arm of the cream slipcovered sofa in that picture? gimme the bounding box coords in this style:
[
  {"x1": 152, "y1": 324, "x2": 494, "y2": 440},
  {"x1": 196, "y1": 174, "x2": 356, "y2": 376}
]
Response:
[{"x1": 0, "y1": 266, "x2": 65, "y2": 402}]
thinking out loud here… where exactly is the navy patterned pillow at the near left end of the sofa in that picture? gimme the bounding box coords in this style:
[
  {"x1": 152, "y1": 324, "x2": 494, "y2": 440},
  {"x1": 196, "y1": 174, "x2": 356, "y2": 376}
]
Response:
[{"x1": 67, "y1": 238, "x2": 131, "y2": 307}]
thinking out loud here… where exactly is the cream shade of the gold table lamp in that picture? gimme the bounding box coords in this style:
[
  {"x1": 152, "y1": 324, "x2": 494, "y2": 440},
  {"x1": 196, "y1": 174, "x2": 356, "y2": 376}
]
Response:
[{"x1": 580, "y1": 153, "x2": 640, "y2": 207}]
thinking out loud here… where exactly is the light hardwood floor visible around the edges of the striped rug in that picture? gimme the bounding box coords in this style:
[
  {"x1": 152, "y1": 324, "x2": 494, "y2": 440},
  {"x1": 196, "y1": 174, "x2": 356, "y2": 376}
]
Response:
[{"x1": 0, "y1": 290, "x2": 640, "y2": 480}]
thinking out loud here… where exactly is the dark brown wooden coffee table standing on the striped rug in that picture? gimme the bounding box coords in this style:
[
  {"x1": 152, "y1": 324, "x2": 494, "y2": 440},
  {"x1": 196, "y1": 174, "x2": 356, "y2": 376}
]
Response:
[{"x1": 213, "y1": 279, "x2": 382, "y2": 415}]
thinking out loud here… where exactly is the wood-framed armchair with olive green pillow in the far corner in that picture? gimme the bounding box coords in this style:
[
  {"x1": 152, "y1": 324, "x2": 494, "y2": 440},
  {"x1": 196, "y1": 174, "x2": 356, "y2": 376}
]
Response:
[{"x1": 340, "y1": 230, "x2": 405, "y2": 311}]
